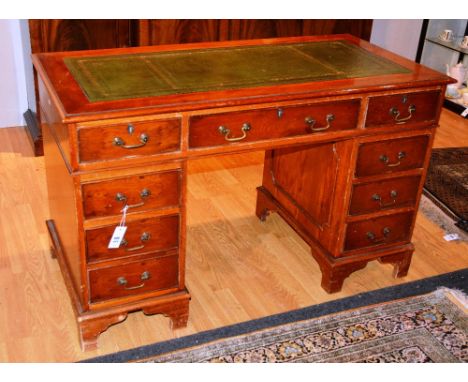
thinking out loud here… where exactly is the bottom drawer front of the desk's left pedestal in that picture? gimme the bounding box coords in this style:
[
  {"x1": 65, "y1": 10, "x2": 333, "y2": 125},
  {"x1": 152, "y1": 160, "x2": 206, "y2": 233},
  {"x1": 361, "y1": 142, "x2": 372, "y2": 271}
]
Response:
[{"x1": 88, "y1": 255, "x2": 179, "y2": 302}]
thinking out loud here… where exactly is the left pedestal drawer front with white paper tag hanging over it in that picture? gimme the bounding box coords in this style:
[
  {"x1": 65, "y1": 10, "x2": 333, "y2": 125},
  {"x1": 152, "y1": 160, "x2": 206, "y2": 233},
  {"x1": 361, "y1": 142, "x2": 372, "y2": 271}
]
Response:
[{"x1": 86, "y1": 215, "x2": 179, "y2": 262}]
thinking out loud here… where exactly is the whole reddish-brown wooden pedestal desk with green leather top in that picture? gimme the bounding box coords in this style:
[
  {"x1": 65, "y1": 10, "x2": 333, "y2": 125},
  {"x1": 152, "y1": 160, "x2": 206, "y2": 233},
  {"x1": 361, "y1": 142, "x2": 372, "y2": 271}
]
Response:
[{"x1": 33, "y1": 35, "x2": 451, "y2": 349}]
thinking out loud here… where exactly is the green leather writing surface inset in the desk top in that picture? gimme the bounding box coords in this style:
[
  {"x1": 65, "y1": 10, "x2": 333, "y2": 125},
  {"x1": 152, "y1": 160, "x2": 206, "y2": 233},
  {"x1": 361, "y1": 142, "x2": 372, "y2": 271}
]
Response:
[{"x1": 64, "y1": 40, "x2": 410, "y2": 102}]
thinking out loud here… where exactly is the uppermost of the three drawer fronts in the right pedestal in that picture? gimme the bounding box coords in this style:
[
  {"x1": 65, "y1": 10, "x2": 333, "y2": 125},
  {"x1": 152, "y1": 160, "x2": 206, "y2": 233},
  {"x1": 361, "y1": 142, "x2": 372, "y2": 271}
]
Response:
[{"x1": 356, "y1": 135, "x2": 429, "y2": 177}]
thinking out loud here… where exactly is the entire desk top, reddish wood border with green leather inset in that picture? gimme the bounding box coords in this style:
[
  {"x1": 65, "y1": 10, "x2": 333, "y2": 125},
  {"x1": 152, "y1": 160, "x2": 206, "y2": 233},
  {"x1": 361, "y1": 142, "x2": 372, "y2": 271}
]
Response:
[{"x1": 33, "y1": 35, "x2": 452, "y2": 122}]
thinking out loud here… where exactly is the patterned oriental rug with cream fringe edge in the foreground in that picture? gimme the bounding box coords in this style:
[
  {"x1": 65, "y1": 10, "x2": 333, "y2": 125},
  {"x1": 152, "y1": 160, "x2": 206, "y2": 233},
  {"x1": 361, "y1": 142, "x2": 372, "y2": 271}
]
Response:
[{"x1": 144, "y1": 289, "x2": 468, "y2": 363}]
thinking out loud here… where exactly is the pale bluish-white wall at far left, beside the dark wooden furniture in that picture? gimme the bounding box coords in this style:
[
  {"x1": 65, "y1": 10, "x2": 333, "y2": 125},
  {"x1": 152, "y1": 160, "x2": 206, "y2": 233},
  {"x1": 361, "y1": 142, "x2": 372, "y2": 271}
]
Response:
[{"x1": 0, "y1": 20, "x2": 28, "y2": 127}]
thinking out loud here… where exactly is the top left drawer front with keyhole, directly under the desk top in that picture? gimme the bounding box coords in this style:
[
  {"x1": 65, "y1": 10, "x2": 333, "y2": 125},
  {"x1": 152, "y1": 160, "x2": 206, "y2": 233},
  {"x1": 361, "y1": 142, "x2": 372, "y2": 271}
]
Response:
[{"x1": 78, "y1": 119, "x2": 180, "y2": 162}]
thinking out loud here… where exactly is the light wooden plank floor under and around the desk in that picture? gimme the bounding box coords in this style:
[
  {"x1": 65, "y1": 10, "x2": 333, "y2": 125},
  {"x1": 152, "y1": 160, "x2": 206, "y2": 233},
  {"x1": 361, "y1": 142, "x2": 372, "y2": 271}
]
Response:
[{"x1": 0, "y1": 111, "x2": 468, "y2": 362}]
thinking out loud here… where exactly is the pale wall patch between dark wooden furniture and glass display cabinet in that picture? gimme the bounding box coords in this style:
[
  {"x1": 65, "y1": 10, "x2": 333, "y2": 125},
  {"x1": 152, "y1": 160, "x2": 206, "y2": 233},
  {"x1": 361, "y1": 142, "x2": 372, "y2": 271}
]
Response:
[{"x1": 370, "y1": 20, "x2": 422, "y2": 60}]
